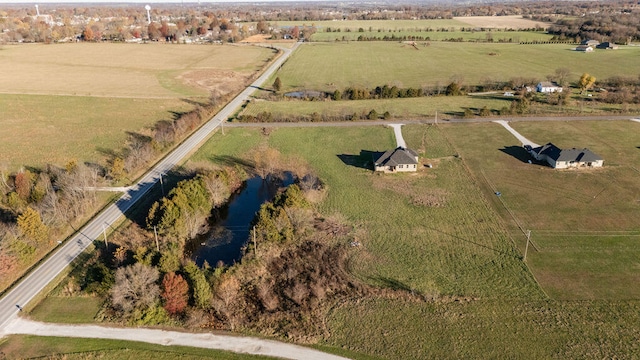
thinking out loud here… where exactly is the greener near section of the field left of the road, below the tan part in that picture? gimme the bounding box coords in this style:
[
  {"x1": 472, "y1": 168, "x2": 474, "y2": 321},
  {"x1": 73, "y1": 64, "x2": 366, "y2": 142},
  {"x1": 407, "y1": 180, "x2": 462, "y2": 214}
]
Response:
[{"x1": 0, "y1": 95, "x2": 193, "y2": 170}]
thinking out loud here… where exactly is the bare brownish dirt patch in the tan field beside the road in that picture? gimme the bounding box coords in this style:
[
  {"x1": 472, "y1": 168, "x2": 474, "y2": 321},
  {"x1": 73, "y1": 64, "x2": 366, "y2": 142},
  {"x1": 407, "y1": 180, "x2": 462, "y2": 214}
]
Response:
[{"x1": 178, "y1": 69, "x2": 248, "y2": 95}]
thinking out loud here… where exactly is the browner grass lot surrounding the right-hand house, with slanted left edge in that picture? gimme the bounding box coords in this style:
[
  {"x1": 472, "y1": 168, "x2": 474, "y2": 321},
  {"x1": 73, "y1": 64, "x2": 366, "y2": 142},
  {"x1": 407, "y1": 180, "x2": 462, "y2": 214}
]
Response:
[{"x1": 443, "y1": 121, "x2": 640, "y2": 300}]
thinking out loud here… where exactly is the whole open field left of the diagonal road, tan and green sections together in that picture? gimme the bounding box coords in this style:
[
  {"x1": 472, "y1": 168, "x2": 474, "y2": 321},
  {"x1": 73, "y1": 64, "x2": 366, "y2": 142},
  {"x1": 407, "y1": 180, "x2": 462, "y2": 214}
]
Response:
[{"x1": 0, "y1": 43, "x2": 272, "y2": 170}]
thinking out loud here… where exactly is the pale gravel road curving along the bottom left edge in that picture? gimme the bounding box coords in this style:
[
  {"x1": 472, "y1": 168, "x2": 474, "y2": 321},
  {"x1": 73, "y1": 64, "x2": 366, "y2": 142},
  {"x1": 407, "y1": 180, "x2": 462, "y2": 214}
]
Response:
[{"x1": 0, "y1": 317, "x2": 346, "y2": 360}]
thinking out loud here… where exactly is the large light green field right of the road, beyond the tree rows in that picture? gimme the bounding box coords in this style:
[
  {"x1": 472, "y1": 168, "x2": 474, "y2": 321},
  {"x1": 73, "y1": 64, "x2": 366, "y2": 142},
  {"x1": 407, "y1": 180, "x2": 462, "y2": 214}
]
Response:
[{"x1": 275, "y1": 41, "x2": 640, "y2": 91}]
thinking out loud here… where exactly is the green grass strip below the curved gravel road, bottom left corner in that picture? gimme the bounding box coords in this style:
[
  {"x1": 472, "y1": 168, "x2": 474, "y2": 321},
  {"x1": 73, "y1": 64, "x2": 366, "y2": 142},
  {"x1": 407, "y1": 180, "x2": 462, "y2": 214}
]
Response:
[{"x1": 0, "y1": 335, "x2": 273, "y2": 360}]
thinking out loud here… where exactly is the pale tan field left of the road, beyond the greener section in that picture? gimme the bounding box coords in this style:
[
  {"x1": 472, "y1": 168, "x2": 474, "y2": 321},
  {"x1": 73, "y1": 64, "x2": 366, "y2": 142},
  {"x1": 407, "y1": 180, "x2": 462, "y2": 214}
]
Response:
[{"x1": 0, "y1": 43, "x2": 273, "y2": 98}]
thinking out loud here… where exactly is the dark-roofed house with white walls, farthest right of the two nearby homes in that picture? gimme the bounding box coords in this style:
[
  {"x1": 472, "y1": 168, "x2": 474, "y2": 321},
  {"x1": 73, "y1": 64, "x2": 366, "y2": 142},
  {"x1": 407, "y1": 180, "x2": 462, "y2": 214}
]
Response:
[{"x1": 524, "y1": 143, "x2": 604, "y2": 169}]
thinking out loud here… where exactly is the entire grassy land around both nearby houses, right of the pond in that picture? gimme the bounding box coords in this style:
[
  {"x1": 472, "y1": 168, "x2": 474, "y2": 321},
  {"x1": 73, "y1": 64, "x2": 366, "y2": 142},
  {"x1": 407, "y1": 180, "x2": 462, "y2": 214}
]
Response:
[{"x1": 27, "y1": 121, "x2": 640, "y2": 359}]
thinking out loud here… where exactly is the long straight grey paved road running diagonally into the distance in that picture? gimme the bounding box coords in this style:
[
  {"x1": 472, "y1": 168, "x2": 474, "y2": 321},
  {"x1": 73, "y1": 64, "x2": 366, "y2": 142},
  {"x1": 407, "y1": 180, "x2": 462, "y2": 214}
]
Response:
[{"x1": 0, "y1": 43, "x2": 299, "y2": 333}]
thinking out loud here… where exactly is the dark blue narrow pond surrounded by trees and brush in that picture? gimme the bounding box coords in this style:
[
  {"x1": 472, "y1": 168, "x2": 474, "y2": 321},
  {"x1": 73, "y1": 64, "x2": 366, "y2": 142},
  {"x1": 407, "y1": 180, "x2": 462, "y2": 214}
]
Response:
[{"x1": 187, "y1": 173, "x2": 294, "y2": 266}]
